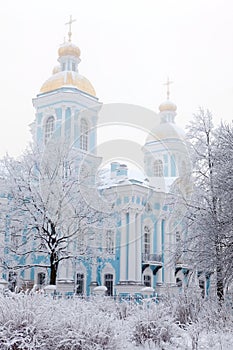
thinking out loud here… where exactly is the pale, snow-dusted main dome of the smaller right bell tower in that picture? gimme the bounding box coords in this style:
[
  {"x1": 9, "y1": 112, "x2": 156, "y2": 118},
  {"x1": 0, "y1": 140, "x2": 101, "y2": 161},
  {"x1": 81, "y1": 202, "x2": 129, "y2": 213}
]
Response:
[{"x1": 146, "y1": 123, "x2": 185, "y2": 142}]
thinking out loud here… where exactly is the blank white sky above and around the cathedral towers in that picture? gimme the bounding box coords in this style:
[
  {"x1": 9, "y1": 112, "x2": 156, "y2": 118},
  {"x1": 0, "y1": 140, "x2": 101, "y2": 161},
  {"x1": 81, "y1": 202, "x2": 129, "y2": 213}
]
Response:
[{"x1": 0, "y1": 0, "x2": 233, "y2": 156}]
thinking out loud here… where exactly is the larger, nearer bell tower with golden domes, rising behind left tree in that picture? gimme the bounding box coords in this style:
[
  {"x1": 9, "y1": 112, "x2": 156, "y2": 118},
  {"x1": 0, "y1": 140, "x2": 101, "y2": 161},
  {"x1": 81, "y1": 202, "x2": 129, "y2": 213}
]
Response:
[{"x1": 32, "y1": 18, "x2": 102, "y2": 155}]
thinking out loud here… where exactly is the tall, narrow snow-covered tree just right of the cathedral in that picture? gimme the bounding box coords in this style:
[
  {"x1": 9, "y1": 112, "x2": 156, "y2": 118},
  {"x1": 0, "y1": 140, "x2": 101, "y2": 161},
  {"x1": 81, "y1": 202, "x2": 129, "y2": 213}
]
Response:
[{"x1": 181, "y1": 109, "x2": 233, "y2": 301}]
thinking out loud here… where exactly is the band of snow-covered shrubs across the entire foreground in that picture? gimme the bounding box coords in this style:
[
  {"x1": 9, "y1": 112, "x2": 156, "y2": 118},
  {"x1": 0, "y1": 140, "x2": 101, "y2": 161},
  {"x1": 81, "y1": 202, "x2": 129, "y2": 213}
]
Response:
[{"x1": 0, "y1": 293, "x2": 233, "y2": 350}]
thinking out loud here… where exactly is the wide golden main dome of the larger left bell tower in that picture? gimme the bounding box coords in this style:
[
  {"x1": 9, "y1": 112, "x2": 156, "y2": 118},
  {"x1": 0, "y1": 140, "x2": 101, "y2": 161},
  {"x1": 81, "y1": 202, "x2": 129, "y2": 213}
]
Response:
[{"x1": 40, "y1": 71, "x2": 96, "y2": 96}]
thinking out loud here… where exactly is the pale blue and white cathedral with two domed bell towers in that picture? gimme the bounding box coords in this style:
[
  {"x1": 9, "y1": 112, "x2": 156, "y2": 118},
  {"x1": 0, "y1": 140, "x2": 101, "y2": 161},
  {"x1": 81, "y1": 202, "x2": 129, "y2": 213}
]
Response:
[{"x1": 0, "y1": 19, "x2": 192, "y2": 296}]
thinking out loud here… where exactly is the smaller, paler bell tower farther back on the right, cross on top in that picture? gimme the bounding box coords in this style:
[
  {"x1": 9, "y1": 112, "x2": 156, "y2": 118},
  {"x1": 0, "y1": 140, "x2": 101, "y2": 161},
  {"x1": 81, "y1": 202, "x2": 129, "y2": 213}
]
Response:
[{"x1": 143, "y1": 79, "x2": 189, "y2": 192}]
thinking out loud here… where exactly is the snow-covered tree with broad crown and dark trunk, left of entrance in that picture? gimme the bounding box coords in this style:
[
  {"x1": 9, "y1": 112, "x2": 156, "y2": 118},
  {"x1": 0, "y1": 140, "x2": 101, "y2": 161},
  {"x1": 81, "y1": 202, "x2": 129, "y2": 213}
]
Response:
[{"x1": 1, "y1": 143, "x2": 110, "y2": 284}]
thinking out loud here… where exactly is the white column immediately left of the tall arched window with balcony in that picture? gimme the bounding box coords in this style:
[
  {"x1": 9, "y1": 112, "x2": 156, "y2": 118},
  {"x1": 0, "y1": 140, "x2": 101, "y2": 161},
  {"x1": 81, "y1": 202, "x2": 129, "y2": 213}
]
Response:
[{"x1": 135, "y1": 214, "x2": 142, "y2": 282}]
